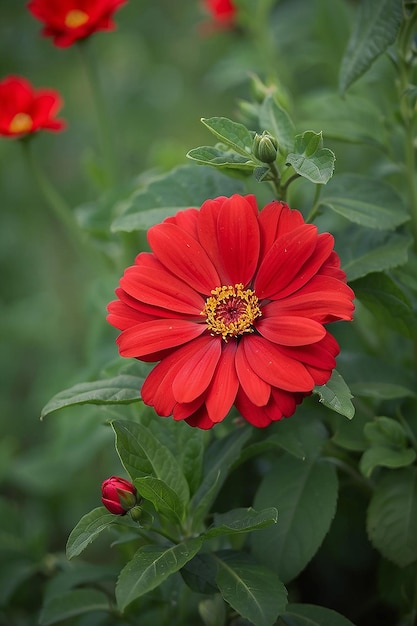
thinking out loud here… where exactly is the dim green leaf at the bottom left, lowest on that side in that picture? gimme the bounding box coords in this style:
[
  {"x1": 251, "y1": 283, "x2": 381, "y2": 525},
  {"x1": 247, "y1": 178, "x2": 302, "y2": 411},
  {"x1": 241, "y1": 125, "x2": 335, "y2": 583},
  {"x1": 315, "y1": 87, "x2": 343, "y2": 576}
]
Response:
[{"x1": 39, "y1": 589, "x2": 110, "y2": 626}]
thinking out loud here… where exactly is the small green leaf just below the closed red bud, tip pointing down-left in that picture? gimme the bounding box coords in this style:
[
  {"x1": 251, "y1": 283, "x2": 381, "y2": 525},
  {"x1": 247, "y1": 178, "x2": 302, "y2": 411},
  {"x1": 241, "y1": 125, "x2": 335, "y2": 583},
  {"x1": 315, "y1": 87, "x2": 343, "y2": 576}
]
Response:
[{"x1": 67, "y1": 506, "x2": 140, "y2": 559}]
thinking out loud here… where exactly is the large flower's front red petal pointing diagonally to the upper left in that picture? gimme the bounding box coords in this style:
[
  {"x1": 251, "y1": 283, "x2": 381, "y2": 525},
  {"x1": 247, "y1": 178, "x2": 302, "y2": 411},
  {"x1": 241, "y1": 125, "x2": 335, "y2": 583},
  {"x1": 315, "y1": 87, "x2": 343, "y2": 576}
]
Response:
[{"x1": 148, "y1": 223, "x2": 220, "y2": 295}]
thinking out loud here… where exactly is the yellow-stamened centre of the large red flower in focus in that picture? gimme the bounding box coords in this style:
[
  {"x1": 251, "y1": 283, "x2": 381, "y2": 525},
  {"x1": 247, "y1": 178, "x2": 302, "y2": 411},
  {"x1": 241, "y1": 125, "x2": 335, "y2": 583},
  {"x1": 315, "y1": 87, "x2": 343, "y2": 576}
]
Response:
[{"x1": 201, "y1": 283, "x2": 262, "y2": 341}]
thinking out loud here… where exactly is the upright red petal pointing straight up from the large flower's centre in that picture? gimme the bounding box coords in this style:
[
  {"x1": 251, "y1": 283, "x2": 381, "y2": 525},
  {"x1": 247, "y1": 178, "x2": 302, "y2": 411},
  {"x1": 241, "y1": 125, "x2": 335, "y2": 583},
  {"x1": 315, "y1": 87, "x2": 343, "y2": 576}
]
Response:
[{"x1": 217, "y1": 195, "x2": 260, "y2": 285}]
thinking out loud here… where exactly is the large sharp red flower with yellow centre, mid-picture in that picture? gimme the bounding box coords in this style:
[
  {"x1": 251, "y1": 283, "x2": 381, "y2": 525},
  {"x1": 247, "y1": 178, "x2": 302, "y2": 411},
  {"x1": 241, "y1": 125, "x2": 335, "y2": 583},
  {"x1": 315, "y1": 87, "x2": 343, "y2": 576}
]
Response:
[{"x1": 108, "y1": 195, "x2": 354, "y2": 428}]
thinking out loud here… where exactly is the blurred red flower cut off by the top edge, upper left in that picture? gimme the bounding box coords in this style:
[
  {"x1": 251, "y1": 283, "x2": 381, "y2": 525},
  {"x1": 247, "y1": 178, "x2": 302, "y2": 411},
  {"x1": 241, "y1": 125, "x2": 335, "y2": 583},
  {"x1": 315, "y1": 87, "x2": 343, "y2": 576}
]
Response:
[{"x1": 27, "y1": 0, "x2": 127, "y2": 48}]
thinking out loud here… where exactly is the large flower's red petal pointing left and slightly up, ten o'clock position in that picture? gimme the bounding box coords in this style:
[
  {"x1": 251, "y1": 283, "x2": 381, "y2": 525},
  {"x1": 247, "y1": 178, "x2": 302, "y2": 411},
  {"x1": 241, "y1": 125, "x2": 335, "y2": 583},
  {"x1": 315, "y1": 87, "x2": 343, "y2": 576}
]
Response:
[{"x1": 120, "y1": 265, "x2": 205, "y2": 316}]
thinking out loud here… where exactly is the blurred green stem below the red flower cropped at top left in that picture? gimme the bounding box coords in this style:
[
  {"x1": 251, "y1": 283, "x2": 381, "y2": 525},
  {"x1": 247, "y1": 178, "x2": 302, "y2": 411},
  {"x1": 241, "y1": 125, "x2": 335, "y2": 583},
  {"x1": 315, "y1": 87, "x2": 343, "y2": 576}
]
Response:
[{"x1": 78, "y1": 39, "x2": 117, "y2": 187}]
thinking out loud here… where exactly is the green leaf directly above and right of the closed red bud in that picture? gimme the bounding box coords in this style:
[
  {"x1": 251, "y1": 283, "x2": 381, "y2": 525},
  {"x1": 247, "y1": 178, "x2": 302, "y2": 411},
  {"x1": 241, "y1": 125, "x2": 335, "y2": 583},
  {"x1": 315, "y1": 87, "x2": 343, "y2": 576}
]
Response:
[{"x1": 112, "y1": 421, "x2": 190, "y2": 506}]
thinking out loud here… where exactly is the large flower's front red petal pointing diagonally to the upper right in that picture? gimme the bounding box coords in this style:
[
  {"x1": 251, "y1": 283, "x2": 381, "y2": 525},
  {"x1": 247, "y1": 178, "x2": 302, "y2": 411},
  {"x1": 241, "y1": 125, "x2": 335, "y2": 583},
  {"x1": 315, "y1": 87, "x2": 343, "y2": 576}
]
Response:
[{"x1": 255, "y1": 224, "x2": 317, "y2": 298}]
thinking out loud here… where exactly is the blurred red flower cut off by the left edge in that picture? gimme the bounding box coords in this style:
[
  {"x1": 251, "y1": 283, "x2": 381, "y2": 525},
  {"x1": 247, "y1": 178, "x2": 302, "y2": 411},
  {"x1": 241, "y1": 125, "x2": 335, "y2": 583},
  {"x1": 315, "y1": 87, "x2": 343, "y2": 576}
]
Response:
[{"x1": 0, "y1": 76, "x2": 65, "y2": 137}]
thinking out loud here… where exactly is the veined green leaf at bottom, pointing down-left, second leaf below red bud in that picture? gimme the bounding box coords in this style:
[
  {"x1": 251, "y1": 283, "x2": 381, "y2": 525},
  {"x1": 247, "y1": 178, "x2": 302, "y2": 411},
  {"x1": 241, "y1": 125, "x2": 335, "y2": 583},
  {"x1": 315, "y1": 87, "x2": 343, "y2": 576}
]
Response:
[{"x1": 116, "y1": 537, "x2": 202, "y2": 611}]
